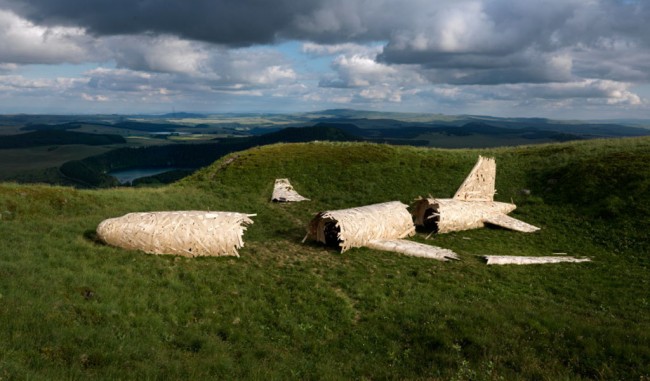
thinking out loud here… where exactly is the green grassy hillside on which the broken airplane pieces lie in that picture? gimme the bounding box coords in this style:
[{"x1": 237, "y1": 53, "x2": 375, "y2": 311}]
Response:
[{"x1": 0, "y1": 138, "x2": 650, "y2": 380}]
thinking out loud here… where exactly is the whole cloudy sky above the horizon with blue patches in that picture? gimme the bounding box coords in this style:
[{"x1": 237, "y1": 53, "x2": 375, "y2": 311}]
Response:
[{"x1": 0, "y1": 0, "x2": 650, "y2": 119}]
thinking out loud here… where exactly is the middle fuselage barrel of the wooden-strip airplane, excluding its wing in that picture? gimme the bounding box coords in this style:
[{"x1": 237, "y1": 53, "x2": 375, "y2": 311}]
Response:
[{"x1": 308, "y1": 201, "x2": 415, "y2": 252}]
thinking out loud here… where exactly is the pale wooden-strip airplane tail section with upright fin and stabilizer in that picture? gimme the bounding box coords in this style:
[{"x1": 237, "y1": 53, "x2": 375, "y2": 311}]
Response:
[{"x1": 413, "y1": 156, "x2": 539, "y2": 233}]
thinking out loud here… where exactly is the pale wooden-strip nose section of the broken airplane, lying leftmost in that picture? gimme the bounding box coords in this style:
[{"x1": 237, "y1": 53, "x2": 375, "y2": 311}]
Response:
[{"x1": 97, "y1": 211, "x2": 255, "y2": 257}]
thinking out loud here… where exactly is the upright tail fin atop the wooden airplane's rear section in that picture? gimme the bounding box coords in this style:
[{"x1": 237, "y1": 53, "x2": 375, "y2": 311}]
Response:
[{"x1": 454, "y1": 156, "x2": 497, "y2": 201}]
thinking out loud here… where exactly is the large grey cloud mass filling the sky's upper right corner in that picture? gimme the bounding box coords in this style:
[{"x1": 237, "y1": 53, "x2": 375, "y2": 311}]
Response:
[{"x1": 378, "y1": 0, "x2": 650, "y2": 84}]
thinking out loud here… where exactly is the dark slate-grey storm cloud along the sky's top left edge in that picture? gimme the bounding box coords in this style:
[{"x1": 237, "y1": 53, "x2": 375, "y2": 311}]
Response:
[{"x1": 5, "y1": 0, "x2": 340, "y2": 46}]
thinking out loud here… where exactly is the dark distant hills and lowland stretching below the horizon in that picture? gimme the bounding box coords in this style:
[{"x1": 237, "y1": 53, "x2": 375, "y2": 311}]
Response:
[{"x1": 0, "y1": 109, "x2": 650, "y2": 187}]
